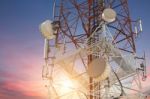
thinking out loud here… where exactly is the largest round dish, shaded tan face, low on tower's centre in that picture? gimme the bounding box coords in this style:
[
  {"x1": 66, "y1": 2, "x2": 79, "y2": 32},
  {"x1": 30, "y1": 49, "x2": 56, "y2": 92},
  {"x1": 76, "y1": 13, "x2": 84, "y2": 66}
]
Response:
[{"x1": 87, "y1": 58, "x2": 109, "y2": 80}]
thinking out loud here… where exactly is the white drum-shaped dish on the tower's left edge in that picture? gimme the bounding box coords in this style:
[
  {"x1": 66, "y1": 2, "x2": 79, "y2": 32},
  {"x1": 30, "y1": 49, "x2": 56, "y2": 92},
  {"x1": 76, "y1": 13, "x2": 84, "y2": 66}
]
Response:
[{"x1": 40, "y1": 20, "x2": 55, "y2": 40}]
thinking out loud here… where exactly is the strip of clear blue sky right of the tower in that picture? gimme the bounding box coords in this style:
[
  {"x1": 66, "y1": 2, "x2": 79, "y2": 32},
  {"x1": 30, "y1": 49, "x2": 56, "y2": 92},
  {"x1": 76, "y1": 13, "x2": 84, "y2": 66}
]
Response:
[{"x1": 129, "y1": 0, "x2": 150, "y2": 62}]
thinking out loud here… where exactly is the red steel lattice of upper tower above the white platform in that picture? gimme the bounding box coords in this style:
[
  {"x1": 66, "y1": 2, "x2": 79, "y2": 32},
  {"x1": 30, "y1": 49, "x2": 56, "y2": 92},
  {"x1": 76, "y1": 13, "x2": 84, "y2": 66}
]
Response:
[{"x1": 55, "y1": 0, "x2": 136, "y2": 53}]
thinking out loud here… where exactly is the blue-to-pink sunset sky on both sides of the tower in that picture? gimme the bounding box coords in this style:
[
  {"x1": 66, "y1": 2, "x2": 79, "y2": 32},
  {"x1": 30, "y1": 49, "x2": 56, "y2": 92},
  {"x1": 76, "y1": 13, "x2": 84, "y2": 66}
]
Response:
[{"x1": 0, "y1": 0, "x2": 150, "y2": 99}]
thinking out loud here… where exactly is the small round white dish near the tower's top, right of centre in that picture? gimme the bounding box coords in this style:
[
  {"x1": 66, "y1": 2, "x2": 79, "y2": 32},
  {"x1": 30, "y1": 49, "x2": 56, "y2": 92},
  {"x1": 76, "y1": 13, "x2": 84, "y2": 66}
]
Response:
[{"x1": 102, "y1": 8, "x2": 116, "y2": 23}]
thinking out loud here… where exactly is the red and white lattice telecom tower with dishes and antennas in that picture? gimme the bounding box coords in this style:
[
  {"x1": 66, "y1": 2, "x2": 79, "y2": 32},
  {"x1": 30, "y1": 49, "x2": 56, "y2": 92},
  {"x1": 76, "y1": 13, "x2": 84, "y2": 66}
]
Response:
[{"x1": 40, "y1": 0, "x2": 146, "y2": 99}]
